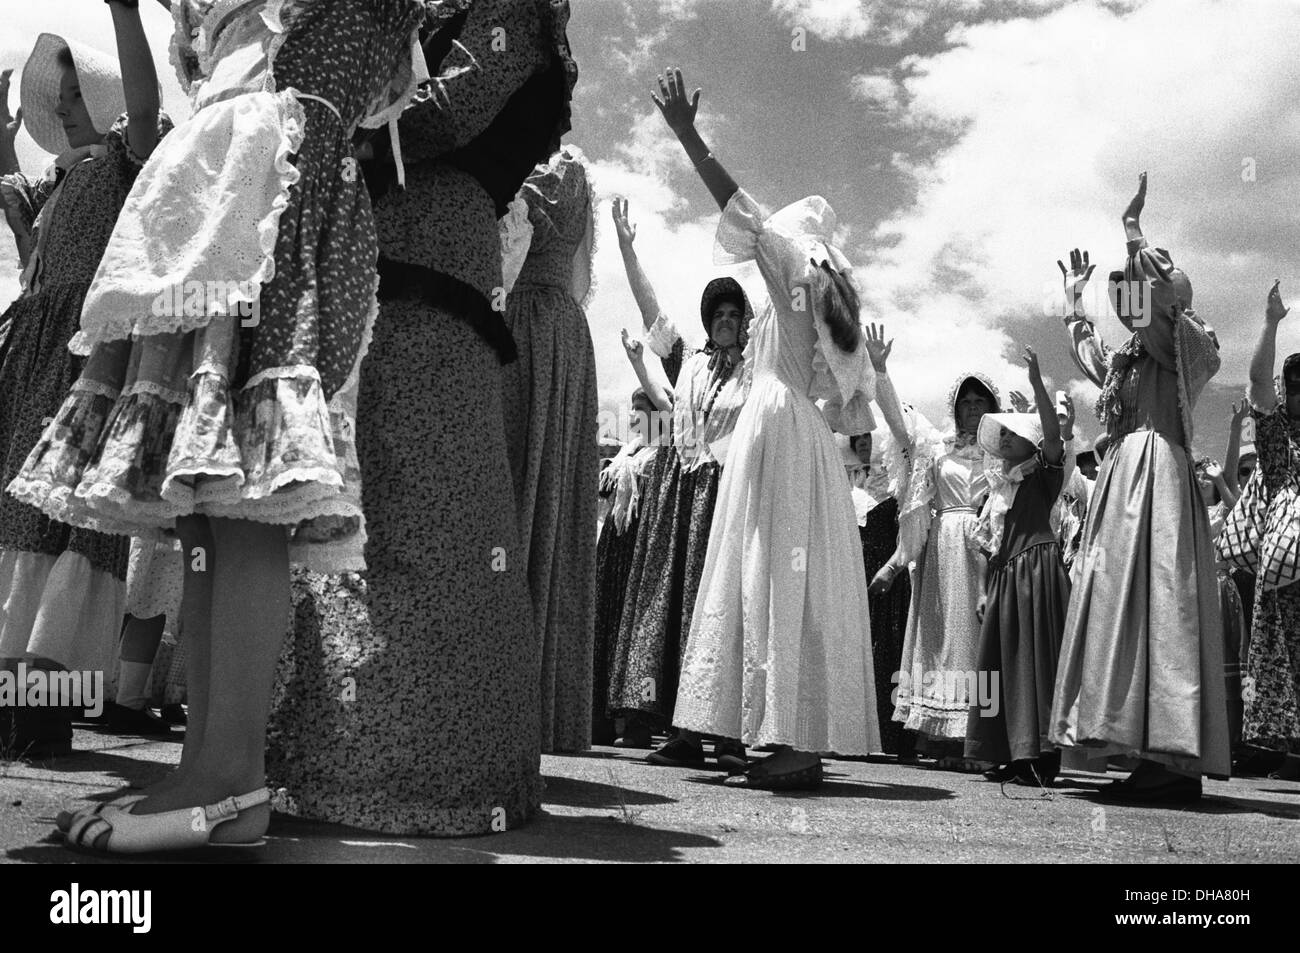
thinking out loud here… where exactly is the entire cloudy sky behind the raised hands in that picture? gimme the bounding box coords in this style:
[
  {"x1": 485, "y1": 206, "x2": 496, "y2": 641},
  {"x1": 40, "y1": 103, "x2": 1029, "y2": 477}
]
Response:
[{"x1": 0, "y1": 0, "x2": 1300, "y2": 456}]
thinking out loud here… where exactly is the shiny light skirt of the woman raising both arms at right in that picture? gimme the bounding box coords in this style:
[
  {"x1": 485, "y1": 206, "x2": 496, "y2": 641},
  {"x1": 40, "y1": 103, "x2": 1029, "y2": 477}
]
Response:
[{"x1": 1052, "y1": 430, "x2": 1231, "y2": 776}]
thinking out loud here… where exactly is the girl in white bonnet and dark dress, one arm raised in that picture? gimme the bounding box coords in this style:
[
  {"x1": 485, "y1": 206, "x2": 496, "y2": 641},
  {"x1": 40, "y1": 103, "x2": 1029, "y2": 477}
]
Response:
[{"x1": 966, "y1": 347, "x2": 1074, "y2": 787}]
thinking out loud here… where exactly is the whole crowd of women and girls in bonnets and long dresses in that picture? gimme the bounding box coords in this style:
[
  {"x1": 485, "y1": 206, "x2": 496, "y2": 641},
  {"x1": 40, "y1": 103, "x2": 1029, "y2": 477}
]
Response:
[{"x1": 0, "y1": 0, "x2": 1300, "y2": 853}]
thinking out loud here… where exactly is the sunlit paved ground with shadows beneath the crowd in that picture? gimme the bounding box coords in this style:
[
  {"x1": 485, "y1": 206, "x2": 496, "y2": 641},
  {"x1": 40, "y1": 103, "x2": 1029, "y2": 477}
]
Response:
[{"x1": 0, "y1": 731, "x2": 1300, "y2": 863}]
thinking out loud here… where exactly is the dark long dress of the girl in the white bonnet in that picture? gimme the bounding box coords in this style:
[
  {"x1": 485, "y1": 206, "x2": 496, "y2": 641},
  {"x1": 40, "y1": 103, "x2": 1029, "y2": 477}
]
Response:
[{"x1": 966, "y1": 464, "x2": 1070, "y2": 763}]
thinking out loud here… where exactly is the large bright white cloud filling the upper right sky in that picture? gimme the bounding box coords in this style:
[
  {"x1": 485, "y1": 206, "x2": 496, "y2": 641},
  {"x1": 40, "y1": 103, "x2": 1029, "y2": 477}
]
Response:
[{"x1": 854, "y1": 0, "x2": 1300, "y2": 439}]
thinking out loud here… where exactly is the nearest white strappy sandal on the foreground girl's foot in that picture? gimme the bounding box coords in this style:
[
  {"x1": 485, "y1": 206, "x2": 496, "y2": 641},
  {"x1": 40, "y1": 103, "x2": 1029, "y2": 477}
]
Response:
[{"x1": 64, "y1": 788, "x2": 270, "y2": 854}]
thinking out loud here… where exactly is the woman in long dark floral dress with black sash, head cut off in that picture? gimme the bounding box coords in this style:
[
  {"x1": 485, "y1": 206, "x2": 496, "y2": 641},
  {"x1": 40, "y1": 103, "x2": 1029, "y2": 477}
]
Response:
[{"x1": 267, "y1": 0, "x2": 579, "y2": 836}]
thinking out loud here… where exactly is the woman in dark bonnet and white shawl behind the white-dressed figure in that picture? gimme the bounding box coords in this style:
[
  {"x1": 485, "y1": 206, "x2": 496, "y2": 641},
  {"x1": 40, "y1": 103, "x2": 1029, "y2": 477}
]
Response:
[{"x1": 610, "y1": 193, "x2": 753, "y2": 766}]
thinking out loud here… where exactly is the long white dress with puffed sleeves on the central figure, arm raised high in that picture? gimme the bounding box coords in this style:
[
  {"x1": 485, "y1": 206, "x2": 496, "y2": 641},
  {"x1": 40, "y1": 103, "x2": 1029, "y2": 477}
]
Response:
[{"x1": 673, "y1": 191, "x2": 880, "y2": 754}]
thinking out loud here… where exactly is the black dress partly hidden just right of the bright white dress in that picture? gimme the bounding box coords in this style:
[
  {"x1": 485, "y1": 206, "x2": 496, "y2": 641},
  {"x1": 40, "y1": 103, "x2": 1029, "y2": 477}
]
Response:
[{"x1": 858, "y1": 497, "x2": 911, "y2": 754}]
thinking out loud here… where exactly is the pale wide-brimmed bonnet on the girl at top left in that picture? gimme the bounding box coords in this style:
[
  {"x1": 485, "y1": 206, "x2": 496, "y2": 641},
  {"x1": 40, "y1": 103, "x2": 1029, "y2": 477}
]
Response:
[{"x1": 21, "y1": 33, "x2": 126, "y2": 156}]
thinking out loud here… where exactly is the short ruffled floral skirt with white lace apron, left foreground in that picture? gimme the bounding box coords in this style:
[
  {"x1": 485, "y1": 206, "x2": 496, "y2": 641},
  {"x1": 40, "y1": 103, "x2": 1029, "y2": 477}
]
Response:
[{"x1": 10, "y1": 94, "x2": 378, "y2": 551}]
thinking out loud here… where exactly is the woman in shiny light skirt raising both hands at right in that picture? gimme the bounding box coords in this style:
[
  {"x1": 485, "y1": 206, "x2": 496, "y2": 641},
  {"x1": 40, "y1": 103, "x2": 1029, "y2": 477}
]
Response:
[{"x1": 1052, "y1": 173, "x2": 1231, "y2": 803}]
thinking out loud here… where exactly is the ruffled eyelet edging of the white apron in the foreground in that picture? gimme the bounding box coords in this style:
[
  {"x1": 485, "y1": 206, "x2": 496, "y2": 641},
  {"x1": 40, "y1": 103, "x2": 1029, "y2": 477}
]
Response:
[{"x1": 68, "y1": 90, "x2": 307, "y2": 356}]
